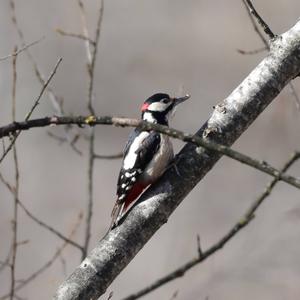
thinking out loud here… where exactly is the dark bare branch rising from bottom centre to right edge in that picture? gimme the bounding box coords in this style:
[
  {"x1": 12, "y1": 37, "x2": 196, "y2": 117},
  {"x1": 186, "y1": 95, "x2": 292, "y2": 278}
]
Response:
[{"x1": 122, "y1": 152, "x2": 300, "y2": 300}]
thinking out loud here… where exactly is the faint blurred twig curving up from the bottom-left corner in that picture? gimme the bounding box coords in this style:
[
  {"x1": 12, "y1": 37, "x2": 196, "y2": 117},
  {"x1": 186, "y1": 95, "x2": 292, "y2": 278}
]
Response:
[{"x1": 0, "y1": 213, "x2": 82, "y2": 300}]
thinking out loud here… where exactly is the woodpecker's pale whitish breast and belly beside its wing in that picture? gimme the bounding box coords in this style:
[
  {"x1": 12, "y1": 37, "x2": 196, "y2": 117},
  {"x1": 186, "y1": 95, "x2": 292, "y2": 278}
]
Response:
[{"x1": 139, "y1": 134, "x2": 174, "y2": 183}]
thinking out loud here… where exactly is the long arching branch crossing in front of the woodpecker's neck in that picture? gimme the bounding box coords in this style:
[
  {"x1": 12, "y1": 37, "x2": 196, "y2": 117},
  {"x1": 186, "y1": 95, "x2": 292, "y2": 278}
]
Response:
[{"x1": 0, "y1": 116, "x2": 300, "y2": 188}]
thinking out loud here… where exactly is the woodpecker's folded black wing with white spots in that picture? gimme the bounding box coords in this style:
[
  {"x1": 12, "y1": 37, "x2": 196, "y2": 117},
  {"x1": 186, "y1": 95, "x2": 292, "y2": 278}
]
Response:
[{"x1": 117, "y1": 129, "x2": 160, "y2": 203}]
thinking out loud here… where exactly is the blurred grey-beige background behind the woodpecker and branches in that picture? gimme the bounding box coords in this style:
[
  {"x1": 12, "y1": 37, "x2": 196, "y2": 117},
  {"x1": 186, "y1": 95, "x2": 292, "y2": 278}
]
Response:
[{"x1": 0, "y1": 0, "x2": 300, "y2": 300}]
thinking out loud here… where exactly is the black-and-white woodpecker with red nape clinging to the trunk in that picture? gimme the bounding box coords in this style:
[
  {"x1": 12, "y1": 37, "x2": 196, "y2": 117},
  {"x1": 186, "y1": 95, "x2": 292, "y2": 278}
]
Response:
[{"x1": 111, "y1": 93, "x2": 190, "y2": 228}]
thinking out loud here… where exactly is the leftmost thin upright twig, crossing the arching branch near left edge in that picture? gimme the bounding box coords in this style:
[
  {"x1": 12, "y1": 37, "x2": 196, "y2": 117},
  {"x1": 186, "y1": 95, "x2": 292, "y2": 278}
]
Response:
[{"x1": 10, "y1": 47, "x2": 19, "y2": 300}]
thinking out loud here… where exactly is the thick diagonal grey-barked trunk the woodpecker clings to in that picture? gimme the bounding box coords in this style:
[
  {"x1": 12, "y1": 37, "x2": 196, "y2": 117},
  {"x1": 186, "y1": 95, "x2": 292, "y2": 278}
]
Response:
[{"x1": 54, "y1": 21, "x2": 300, "y2": 300}]
